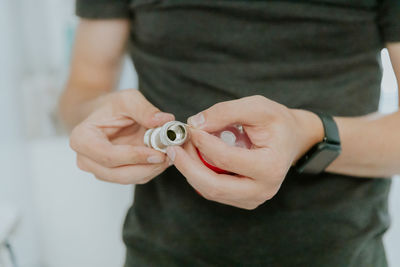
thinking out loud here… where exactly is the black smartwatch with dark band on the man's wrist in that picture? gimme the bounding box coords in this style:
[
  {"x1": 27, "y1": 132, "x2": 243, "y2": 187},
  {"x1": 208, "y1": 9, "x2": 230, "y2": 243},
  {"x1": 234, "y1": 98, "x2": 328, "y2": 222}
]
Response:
[{"x1": 295, "y1": 112, "x2": 342, "y2": 174}]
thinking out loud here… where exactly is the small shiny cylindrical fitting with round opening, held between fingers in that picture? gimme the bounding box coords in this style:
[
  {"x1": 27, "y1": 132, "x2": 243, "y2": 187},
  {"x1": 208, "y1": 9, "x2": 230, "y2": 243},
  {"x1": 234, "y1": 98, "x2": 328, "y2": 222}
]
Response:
[{"x1": 143, "y1": 121, "x2": 189, "y2": 153}]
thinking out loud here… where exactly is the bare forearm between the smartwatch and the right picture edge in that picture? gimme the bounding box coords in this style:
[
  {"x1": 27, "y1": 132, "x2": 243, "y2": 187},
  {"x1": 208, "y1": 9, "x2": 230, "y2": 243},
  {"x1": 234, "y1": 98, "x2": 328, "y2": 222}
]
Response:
[{"x1": 327, "y1": 111, "x2": 400, "y2": 177}]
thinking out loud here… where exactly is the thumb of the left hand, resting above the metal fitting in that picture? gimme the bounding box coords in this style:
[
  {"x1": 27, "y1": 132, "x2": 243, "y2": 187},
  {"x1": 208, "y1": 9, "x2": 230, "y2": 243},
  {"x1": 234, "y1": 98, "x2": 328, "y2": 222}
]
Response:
[{"x1": 124, "y1": 90, "x2": 175, "y2": 128}]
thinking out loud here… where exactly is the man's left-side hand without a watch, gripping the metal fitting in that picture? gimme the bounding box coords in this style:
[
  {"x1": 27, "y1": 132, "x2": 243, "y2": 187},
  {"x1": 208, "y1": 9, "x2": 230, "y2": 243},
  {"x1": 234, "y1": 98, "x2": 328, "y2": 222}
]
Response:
[{"x1": 70, "y1": 90, "x2": 174, "y2": 184}]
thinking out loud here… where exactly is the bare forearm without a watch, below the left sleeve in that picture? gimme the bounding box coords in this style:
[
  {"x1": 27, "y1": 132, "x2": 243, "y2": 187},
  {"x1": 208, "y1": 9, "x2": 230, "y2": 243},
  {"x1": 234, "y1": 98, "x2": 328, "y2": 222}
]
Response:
[{"x1": 59, "y1": 19, "x2": 130, "y2": 129}]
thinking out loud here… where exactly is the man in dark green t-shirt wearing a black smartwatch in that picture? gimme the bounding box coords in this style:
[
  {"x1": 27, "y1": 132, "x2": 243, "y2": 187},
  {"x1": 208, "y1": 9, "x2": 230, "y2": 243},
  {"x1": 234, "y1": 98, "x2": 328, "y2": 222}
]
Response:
[{"x1": 60, "y1": 0, "x2": 400, "y2": 267}]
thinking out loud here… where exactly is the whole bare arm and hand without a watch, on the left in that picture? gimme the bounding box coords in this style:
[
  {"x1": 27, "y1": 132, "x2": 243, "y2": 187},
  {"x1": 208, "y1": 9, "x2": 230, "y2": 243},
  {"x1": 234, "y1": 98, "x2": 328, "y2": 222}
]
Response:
[{"x1": 59, "y1": 20, "x2": 174, "y2": 184}]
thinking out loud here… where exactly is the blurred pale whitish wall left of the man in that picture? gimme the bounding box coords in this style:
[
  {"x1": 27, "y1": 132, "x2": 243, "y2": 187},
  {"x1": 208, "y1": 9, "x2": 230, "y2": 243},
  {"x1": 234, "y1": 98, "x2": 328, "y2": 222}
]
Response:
[{"x1": 0, "y1": 0, "x2": 136, "y2": 267}]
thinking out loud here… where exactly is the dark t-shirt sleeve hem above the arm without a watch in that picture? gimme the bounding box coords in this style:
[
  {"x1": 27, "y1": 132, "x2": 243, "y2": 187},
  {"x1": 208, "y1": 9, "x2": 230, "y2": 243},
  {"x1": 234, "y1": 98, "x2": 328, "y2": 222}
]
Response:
[{"x1": 76, "y1": 0, "x2": 130, "y2": 19}]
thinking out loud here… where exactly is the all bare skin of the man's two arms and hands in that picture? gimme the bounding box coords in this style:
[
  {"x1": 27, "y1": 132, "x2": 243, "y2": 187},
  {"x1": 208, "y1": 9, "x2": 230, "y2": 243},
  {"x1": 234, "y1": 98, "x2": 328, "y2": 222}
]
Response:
[{"x1": 60, "y1": 20, "x2": 400, "y2": 209}]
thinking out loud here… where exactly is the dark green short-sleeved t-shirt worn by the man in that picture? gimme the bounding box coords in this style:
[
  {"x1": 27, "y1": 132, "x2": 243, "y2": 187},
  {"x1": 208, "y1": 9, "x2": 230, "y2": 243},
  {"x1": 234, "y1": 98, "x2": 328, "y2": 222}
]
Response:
[{"x1": 77, "y1": 0, "x2": 400, "y2": 267}]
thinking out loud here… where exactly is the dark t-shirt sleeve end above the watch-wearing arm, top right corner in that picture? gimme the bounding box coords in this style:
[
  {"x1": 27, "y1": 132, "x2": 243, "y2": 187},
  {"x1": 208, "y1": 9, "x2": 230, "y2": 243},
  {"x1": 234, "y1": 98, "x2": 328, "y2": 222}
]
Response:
[{"x1": 379, "y1": 0, "x2": 400, "y2": 43}]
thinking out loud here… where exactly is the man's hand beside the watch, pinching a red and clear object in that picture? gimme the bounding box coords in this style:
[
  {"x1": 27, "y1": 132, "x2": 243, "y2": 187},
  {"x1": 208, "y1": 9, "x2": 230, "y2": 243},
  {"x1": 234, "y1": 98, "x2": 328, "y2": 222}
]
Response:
[{"x1": 168, "y1": 96, "x2": 324, "y2": 209}]
